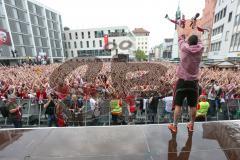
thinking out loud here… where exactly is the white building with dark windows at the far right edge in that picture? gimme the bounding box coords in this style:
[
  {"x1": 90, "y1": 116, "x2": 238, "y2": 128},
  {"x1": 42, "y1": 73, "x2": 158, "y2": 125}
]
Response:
[{"x1": 208, "y1": 0, "x2": 240, "y2": 61}]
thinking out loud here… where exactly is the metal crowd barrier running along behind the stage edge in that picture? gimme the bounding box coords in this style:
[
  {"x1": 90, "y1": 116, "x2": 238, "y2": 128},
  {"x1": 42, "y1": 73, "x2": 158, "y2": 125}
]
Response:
[{"x1": 0, "y1": 99, "x2": 240, "y2": 127}]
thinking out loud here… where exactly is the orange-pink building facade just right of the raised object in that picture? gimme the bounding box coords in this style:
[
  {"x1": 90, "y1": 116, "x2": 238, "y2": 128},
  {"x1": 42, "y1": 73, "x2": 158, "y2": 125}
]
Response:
[{"x1": 199, "y1": 0, "x2": 217, "y2": 58}]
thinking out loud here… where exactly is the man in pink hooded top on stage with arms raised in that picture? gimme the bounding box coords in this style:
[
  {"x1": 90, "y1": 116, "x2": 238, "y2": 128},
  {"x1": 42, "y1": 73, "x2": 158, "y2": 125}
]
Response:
[{"x1": 168, "y1": 29, "x2": 204, "y2": 133}]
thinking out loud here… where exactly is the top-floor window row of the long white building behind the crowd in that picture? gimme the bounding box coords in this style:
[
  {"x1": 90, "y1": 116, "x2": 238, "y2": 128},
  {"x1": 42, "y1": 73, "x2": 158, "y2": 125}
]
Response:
[{"x1": 63, "y1": 29, "x2": 127, "y2": 40}]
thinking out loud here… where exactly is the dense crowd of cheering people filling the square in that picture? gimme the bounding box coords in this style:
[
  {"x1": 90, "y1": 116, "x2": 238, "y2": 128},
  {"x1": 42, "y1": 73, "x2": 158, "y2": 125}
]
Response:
[{"x1": 0, "y1": 62, "x2": 240, "y2": 127}]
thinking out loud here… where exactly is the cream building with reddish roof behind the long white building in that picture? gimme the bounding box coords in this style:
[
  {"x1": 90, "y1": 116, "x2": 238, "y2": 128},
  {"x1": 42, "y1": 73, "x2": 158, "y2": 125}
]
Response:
[{"x1": 133, "y1": 28, "x2": 150, "y2": 55}]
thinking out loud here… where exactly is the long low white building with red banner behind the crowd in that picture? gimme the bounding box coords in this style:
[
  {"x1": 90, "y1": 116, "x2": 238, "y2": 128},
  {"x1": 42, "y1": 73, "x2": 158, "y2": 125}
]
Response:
[{"x1": 63, "y1": 26, "x2": 136, "y2": 58}]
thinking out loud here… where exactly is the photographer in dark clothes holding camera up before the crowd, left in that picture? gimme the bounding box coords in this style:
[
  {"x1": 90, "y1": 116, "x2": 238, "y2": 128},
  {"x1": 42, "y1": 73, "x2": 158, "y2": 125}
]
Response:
[{"x1": 43, "y1": 93, "x2": 58, "y2": 127}]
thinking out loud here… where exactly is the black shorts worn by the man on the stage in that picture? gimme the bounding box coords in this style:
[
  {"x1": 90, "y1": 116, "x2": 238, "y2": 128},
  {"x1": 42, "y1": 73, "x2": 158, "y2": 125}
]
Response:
[{"x1": 174, "y1": 79, "x2": 199, "y2": 107}]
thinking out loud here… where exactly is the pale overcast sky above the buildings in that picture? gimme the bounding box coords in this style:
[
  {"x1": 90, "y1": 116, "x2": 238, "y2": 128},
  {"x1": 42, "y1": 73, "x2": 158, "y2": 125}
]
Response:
[{"x1": 37, "y1": 0, "x2": 205, "y2": 47}]
